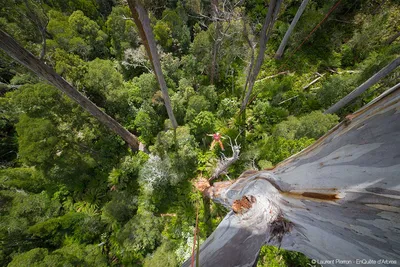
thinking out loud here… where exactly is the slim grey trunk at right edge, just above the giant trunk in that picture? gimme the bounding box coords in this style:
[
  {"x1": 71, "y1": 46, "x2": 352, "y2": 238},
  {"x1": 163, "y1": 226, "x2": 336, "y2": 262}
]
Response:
[{"x1": 324, "y1": 57, "x2": 400, "y2": 114}]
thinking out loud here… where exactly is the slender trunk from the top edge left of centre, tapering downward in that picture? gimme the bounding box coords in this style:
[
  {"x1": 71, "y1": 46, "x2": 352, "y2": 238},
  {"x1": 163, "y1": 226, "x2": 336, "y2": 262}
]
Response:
[{"x1": 128, "y1": 0, "x2": 178, "y2": 129}]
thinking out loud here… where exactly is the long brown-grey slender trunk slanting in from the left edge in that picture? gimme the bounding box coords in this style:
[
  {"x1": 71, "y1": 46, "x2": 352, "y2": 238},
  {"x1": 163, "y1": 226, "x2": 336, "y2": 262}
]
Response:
[{"x1": 0, "y1": 30, "x2": 139, "y2": 150}]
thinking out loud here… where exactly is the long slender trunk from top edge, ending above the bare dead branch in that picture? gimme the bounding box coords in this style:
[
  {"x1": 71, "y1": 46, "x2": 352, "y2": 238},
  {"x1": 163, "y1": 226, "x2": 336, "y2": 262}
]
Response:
[{"x1": 240, "y1": 0, "x2": 282, "y2": 112}]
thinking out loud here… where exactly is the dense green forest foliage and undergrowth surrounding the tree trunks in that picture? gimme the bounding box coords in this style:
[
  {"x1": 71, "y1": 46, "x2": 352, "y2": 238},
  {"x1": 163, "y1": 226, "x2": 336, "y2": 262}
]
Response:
[{"x1": 0, "y1": 0, "x2": 400, "y2": 266}]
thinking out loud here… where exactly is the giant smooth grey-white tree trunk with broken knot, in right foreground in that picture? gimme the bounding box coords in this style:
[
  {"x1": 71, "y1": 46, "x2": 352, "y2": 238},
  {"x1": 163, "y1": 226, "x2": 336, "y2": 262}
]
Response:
[{"x1": 183, "y1": 85, "x2": 400, "y2": 267}]
